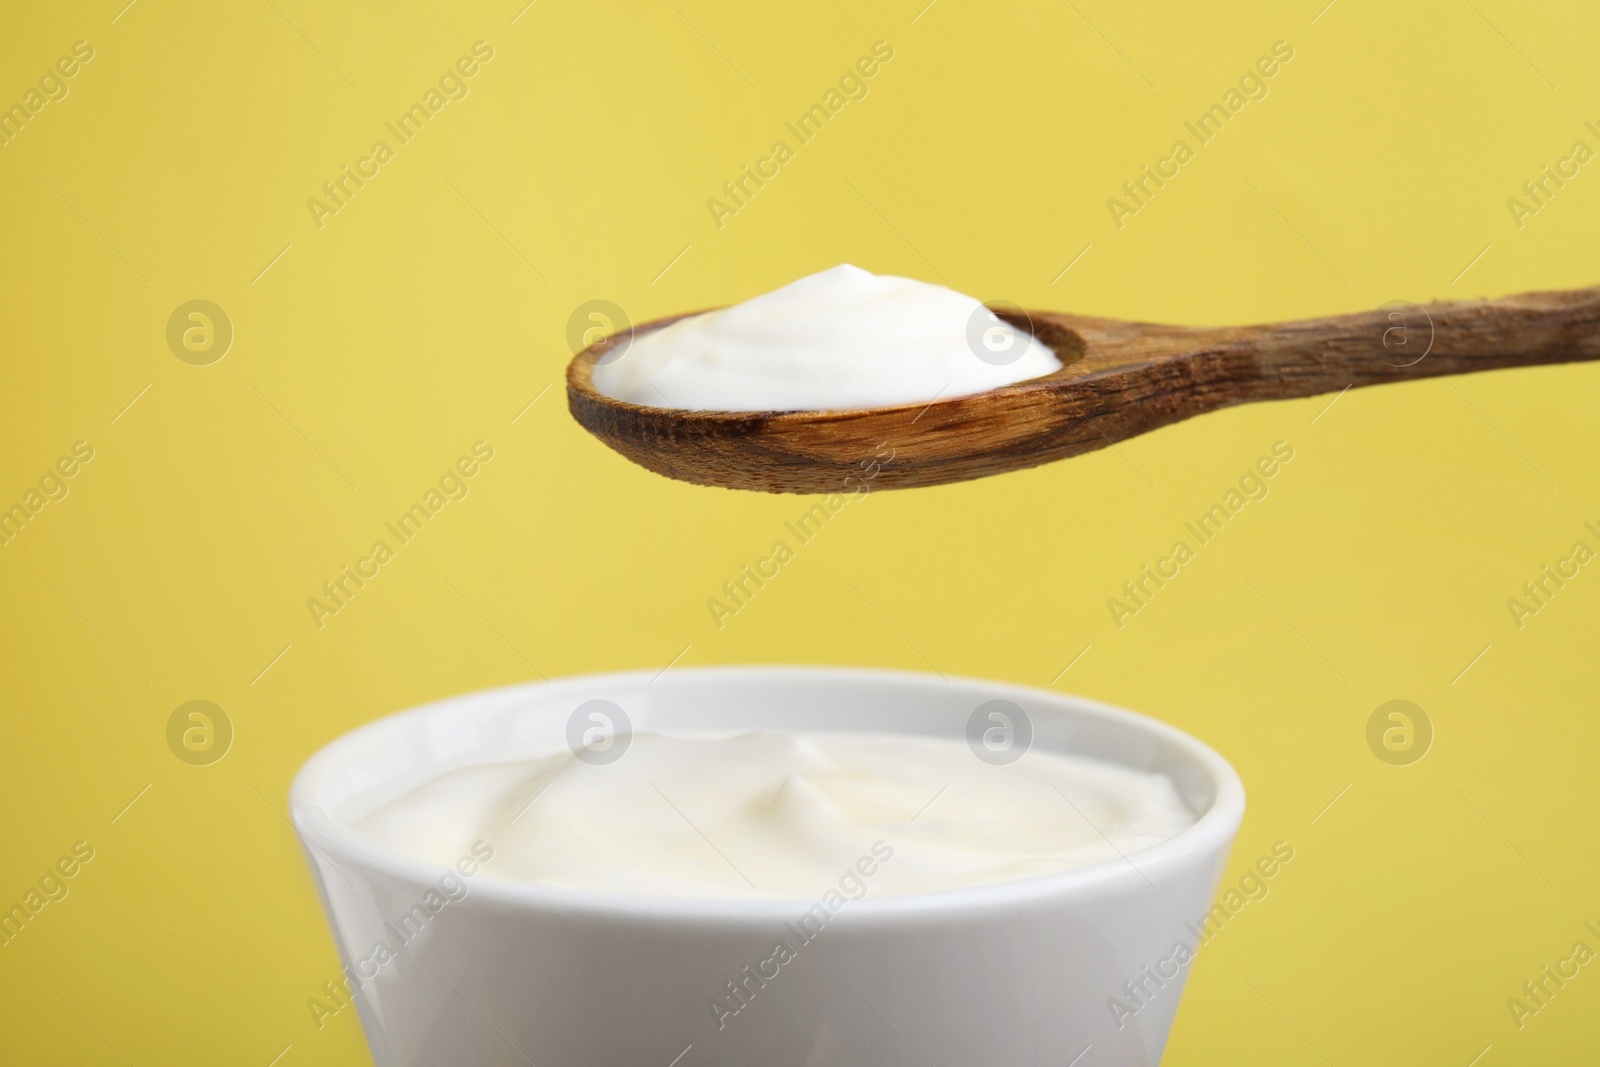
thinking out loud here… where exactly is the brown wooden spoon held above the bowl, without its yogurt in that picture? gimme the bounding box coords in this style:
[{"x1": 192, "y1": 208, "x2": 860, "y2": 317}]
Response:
[{"x1": 566, "y1": 288, "x2": 1600, "y2": 493}]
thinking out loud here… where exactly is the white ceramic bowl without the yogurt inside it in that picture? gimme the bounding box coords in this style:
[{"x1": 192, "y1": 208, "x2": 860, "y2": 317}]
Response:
[{"x1": 290, "y1": 667, "x2": 1245, "y2": 1067}]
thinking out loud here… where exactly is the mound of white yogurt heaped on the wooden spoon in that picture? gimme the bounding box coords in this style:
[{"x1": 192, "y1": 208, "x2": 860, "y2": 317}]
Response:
[{"x1": 594, "y1": 264, "x2": 1061, "y2": 411}]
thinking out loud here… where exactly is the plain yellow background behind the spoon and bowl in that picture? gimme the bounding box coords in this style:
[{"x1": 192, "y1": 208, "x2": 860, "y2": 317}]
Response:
[{"x1": 0, "y1": 0, "x2": 1600, "y2": 1067}]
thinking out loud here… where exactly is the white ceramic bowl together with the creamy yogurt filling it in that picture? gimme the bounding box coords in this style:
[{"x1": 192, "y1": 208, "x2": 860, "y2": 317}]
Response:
[{"x1": 290, "y1": 667, "x2": 1243, "y2": 1067}]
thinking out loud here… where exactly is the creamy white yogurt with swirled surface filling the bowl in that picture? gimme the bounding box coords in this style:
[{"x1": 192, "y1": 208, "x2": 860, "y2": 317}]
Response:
[{"x1": 349, "y1": 733, "x2": 1195, "y2": 899}]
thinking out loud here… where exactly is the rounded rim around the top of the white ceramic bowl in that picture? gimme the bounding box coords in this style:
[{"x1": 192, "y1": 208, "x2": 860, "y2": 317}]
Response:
[{"x1": 288, "y1": 664, "x2": 1245, "y2": 926}]
